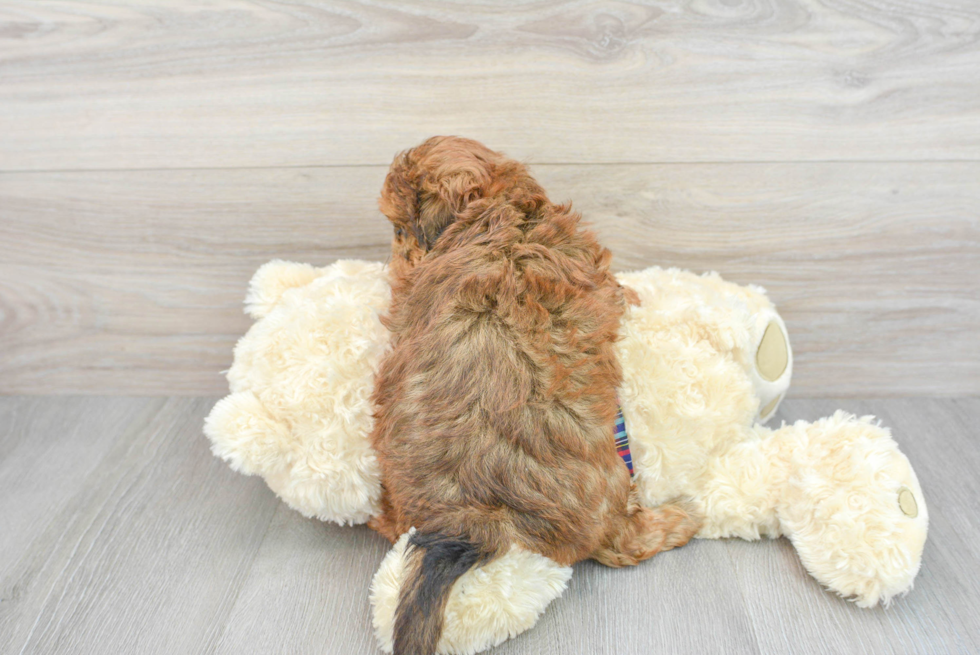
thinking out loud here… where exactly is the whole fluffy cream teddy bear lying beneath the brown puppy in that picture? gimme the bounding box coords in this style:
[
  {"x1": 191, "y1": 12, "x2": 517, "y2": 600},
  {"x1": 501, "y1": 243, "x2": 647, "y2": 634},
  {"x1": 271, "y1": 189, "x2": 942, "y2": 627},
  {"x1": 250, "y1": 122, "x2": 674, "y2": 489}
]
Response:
[{"x1": 205, "y1": 261, "x2": 928, "y2": 653}]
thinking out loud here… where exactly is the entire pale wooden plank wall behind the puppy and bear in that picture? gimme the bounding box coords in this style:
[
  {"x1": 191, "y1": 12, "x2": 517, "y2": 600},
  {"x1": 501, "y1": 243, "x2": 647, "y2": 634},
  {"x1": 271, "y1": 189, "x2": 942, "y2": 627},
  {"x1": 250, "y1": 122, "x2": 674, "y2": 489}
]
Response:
[{"x1": 0, "y1": 0, "x2": 980, "y2": 397}]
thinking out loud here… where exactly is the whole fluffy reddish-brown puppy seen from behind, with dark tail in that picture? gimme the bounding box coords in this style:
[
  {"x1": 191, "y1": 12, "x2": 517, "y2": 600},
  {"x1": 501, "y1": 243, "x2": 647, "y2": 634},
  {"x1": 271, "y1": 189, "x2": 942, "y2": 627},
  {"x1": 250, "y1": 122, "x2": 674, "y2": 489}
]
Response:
[{"x1": 371, "y1": 137, "x2": 699, "y2": 655}]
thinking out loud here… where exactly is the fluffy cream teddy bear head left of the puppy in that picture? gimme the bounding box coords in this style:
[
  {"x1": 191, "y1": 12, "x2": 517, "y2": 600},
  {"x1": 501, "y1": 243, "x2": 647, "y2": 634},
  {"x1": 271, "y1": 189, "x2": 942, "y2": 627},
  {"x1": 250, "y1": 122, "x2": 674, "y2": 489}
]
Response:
[{"x1": 204, "y1": 261, "x2": 391, "y2": 524}]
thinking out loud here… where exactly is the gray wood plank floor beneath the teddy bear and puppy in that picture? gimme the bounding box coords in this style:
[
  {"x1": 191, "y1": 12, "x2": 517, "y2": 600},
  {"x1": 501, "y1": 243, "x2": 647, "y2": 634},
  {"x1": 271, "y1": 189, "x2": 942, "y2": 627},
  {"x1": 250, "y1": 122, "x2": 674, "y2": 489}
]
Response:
[{"x1": 0, "y1": 396, "x2": 980, "y2": 655}]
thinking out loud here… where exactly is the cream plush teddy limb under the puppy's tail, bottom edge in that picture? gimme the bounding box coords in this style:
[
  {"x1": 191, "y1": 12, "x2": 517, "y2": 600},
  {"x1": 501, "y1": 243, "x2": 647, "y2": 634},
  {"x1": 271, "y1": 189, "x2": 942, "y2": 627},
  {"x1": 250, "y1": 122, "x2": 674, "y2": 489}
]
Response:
[{"x1": 371, "y1": 534, "x2": 572, "y2": 654}]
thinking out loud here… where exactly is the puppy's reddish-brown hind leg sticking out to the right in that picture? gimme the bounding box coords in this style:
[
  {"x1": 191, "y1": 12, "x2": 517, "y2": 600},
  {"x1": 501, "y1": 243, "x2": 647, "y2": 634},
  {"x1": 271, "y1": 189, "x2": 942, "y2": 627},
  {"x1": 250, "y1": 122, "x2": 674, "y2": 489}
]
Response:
[{"x1": 592, "y1": 501, "x2": 702, "y2": 567}]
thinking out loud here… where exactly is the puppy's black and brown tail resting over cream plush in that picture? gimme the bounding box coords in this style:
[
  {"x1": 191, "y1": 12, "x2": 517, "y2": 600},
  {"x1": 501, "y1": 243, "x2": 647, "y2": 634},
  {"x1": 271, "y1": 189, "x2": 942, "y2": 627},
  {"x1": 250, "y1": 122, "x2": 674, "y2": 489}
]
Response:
[{"x1": 393, "y1": 532, "x2": 483, "y2": 655}]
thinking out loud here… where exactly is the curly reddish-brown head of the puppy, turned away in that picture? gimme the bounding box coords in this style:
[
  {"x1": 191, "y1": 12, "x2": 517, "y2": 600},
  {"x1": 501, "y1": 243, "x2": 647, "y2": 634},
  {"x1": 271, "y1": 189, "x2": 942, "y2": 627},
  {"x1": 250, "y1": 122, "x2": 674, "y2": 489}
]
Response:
[{"x1": 378, "y1": 136, "x2": 543, "y2": 266}]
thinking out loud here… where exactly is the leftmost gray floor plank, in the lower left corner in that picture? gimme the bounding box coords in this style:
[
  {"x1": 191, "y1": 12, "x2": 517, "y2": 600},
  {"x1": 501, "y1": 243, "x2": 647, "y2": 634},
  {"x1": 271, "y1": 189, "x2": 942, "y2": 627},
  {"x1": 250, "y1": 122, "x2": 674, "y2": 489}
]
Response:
[{"x1": 0, "y1": 397, "x2": 162, "y2": 653}]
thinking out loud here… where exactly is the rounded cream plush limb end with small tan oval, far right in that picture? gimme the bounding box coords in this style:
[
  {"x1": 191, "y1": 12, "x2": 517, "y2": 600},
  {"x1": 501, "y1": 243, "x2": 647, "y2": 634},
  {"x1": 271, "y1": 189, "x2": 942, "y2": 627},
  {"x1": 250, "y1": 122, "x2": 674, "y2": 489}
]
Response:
[{"x1": 774, "y1": 411, "x2": 928, "y2": 607}]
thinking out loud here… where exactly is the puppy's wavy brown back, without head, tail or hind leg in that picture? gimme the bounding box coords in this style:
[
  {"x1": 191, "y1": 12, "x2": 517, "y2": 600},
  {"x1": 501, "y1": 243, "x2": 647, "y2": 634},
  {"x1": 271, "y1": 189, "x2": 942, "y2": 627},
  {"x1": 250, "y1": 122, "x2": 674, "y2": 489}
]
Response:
[{"x1": 376, "y1": 197, "x2": 628, "y2": 561}]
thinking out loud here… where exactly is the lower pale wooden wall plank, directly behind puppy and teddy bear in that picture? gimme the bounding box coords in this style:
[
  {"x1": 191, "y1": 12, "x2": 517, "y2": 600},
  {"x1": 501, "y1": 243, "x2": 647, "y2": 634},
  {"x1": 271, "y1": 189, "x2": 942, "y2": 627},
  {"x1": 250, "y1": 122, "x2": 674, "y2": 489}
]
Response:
[{"x1": 0, "y1": 162, "x2": 980, "y2": 397}]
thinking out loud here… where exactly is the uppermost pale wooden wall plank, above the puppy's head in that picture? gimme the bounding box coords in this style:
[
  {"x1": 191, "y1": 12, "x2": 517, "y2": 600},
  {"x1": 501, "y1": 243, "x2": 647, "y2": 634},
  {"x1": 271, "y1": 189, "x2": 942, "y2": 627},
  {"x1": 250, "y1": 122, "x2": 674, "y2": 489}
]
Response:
[{"x1": 0, "y1": 0, "x2": 980, "y2": 171}]
